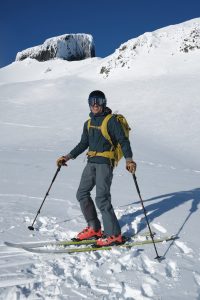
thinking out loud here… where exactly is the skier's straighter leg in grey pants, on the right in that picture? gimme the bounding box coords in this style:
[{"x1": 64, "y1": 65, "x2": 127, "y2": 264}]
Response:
[{"x1": 96, "y1": 164, "x2": 121, "y2": 236}]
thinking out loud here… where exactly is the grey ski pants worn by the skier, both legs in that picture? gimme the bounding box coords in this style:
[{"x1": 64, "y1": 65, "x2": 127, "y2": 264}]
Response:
[{"x1": 76, "y1": 163, "x2": 121, "y2": 236}]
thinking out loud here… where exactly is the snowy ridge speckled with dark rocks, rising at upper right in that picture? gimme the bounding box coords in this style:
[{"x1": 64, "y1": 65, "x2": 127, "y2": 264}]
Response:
[{"x1": 100, "y1": 18, "x2": 200, "y2": 77}]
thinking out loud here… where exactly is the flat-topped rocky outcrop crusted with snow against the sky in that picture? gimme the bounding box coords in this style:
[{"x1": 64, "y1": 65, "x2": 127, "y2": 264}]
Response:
[{"x1": 16, "y1": 33, "x2": 95, "y2": 61}]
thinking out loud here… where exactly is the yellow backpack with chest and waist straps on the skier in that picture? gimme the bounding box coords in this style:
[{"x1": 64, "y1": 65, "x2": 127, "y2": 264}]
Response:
[{"x1": 87, "y1": 114, "x2": 131, "y2": 166}]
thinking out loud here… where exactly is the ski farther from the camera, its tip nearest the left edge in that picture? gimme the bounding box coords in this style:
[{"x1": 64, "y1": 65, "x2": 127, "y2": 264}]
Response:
[{"x1": 4, "y1": 232, "x2": 155, "y2": 249}]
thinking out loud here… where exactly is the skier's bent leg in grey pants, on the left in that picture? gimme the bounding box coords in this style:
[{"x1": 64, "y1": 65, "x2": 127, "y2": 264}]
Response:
[{"x1": 76, "y1": 163, "x2": 101, "y2": 231}]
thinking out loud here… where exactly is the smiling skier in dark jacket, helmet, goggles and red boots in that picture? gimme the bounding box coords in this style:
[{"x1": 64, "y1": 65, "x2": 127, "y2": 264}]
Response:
[{"x1": 57, "y1": 90, "x2": 136, "y2": 247}]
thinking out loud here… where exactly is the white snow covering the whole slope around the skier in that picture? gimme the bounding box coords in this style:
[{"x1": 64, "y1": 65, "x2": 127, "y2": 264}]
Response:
[{"x1": 0, "y1": 19, "x2": 200, "y2": 300}]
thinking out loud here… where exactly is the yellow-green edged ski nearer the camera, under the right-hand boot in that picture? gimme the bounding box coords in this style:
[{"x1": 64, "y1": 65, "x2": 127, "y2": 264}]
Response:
[{"x1": 23, "y1": 235, "x2": 178, "y2": 254}]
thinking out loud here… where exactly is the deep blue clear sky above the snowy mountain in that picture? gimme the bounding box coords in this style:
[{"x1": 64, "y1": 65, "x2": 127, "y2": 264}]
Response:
[{"x1": 0, "y1": 0, "x2": 200, "y2": 67}]
